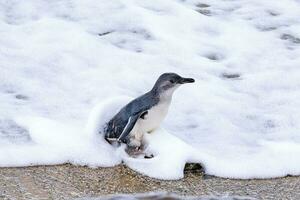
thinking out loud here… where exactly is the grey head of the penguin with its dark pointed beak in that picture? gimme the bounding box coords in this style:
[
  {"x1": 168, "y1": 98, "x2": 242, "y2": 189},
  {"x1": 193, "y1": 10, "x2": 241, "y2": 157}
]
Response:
[{"x1": 153, "y1": 73, "x2": 195, "y2": 94}]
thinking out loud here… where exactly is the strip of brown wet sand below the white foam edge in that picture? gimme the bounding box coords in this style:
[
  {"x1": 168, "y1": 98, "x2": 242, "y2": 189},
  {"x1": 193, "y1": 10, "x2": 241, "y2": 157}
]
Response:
[{"x1": 0, "y1": 164, "x2": 300, "y2": 199}]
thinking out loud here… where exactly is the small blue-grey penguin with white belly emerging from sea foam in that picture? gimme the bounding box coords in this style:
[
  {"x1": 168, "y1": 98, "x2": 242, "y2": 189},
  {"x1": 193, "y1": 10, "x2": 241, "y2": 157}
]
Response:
[{"x1": 104, "y1": 73, "x2": 195, "y2": 148}]
